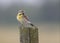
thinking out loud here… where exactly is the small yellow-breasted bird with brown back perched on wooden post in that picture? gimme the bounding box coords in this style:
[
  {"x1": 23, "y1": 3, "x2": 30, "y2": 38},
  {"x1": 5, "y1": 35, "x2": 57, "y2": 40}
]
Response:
[{"x1": 17, "y1": 10, "x2": 34, "y2": 26}]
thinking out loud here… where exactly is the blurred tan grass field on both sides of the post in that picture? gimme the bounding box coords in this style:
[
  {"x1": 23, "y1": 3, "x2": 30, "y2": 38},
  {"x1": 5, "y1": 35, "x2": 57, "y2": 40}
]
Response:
[{"x1": 0, "y1": 24, "x2": 60, "y2": 43}]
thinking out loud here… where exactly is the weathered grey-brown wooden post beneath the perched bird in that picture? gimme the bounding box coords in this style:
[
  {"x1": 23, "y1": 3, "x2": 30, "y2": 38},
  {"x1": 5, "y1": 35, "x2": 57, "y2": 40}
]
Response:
[{"x1": 20, "y1": 27, "x2": 38, "y2": 43}]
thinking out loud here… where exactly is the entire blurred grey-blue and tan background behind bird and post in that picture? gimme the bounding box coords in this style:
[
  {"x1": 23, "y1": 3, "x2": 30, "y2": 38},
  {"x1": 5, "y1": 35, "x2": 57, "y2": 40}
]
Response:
[{"x1": 0, "y1": 0, "x2": 60, "y2": 43}]
